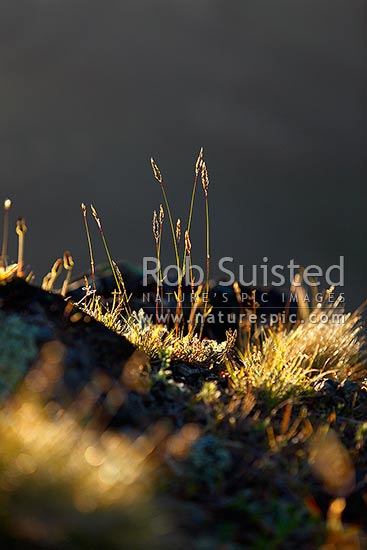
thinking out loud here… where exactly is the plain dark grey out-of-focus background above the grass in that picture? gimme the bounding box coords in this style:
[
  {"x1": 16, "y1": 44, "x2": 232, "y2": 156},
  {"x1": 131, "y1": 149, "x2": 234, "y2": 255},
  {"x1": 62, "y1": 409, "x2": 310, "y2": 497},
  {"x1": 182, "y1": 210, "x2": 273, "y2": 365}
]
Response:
[{"x1": 0, "y1": 0, "x2": 367, "y2": 307}]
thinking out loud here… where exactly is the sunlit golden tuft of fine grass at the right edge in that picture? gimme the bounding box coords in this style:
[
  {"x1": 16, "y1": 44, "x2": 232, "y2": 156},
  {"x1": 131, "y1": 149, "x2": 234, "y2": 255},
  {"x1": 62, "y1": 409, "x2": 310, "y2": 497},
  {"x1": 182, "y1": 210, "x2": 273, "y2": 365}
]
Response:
[{"x1": 228, "y1": 302, "x2": 366, "y2": 399}]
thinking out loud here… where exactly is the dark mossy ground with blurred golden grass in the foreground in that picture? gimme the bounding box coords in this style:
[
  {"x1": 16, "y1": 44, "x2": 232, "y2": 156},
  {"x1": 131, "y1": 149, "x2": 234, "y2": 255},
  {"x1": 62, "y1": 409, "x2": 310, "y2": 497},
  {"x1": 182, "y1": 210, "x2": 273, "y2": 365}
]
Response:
[{"x1": 0, "y1": 280, "x2": 367, "y2": 550}]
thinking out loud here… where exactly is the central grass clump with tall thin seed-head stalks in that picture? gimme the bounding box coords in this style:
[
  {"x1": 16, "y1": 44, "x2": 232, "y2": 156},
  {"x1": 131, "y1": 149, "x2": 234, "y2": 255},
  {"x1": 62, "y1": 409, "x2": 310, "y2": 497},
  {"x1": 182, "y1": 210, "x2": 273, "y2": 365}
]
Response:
[{"x1": 78, "y1": 148, "x2": 236, "y2": 365}]
